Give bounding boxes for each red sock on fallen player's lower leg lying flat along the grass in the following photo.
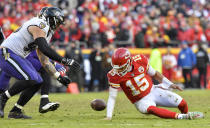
[147,106,176,119]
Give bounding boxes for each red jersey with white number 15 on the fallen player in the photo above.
[107,54,153,103]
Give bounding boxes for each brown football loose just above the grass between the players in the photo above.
[90,99,106,111]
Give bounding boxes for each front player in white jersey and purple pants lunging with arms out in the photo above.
[0,7,80,119]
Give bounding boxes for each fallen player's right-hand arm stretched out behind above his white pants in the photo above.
[147,65,182,91]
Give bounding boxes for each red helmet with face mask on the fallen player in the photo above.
[111,48,132,76]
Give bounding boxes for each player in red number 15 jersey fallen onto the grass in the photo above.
[105,48,204,120]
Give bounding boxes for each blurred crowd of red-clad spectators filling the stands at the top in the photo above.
[0,0,210,48]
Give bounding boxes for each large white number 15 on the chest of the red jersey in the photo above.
[126,73,149,96]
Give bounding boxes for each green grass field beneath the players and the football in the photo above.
[0,90,210,128]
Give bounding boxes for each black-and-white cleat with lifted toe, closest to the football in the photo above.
[39,102,60,113]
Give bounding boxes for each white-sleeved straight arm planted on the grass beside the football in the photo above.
[106,86,118,120]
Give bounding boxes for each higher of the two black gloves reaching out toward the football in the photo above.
[61,58,80,71]
